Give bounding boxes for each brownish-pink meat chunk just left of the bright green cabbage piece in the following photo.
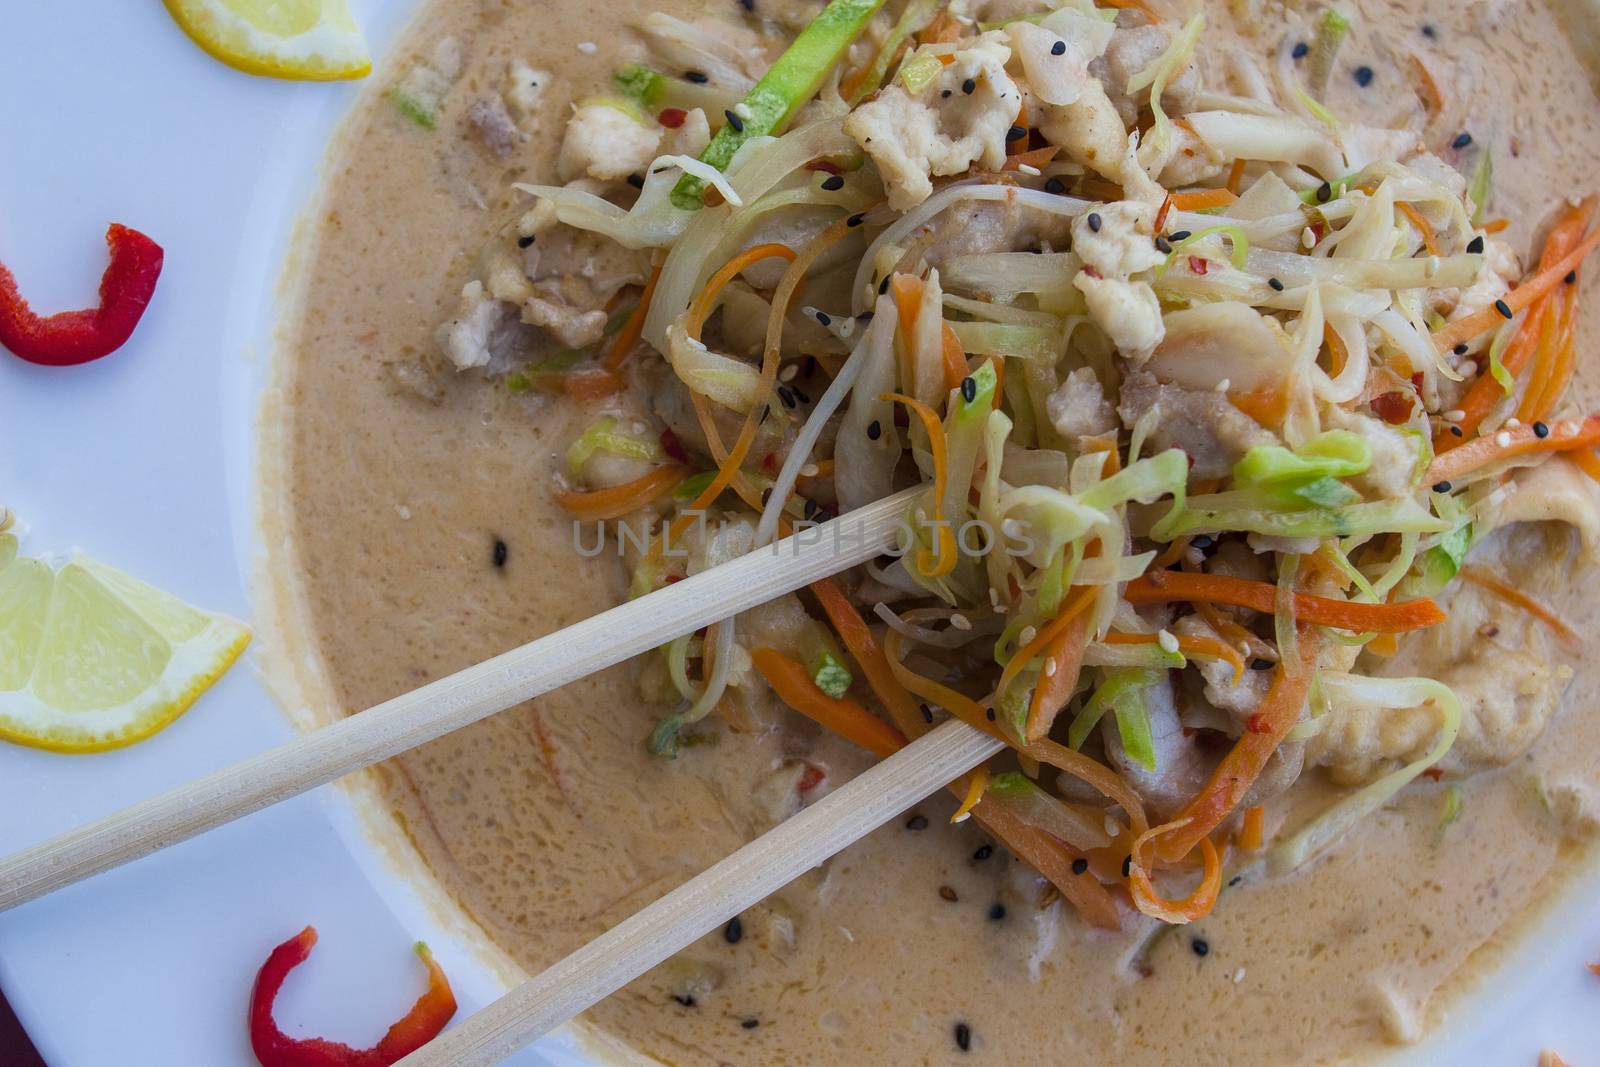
[1117,371,1280,478]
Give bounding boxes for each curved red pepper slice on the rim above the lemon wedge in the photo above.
[0,222,163,366]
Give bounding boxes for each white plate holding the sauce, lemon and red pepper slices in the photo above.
[0,0,1600,1067]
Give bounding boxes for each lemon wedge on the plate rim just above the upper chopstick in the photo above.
[0,534,250,752]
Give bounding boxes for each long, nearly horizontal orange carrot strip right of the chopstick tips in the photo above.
[1123,566,1454,633]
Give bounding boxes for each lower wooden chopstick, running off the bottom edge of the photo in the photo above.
[397,718,1005,1067]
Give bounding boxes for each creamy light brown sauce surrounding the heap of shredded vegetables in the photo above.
[268,0,1600,1067]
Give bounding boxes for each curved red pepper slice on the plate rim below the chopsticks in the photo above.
[250,926,456,1067]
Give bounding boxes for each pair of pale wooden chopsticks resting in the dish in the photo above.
[0,488,1002,1067]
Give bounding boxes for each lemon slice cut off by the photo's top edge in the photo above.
[166,0,373,82]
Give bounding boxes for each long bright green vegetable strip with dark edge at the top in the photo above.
[672,0,883,211]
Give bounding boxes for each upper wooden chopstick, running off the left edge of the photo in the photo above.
[0,488,922,910]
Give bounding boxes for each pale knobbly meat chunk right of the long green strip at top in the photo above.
[845,30,1022,211]
